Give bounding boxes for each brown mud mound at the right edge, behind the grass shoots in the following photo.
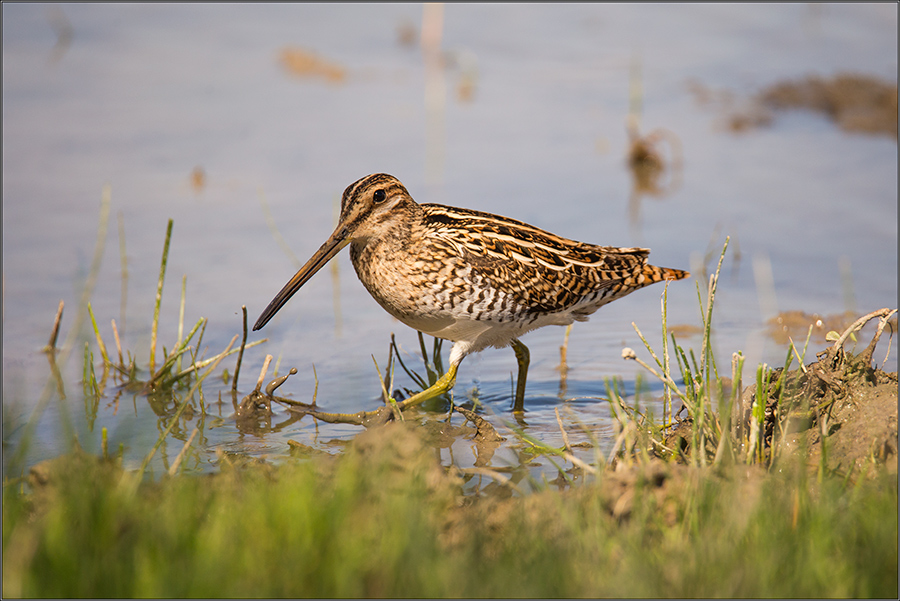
[665,310,898,478]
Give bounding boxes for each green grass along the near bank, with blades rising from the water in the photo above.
[2,205,898,597]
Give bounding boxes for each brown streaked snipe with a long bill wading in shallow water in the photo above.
[253,173,690,411]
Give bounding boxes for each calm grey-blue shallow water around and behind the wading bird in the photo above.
[3,4,897,470]
